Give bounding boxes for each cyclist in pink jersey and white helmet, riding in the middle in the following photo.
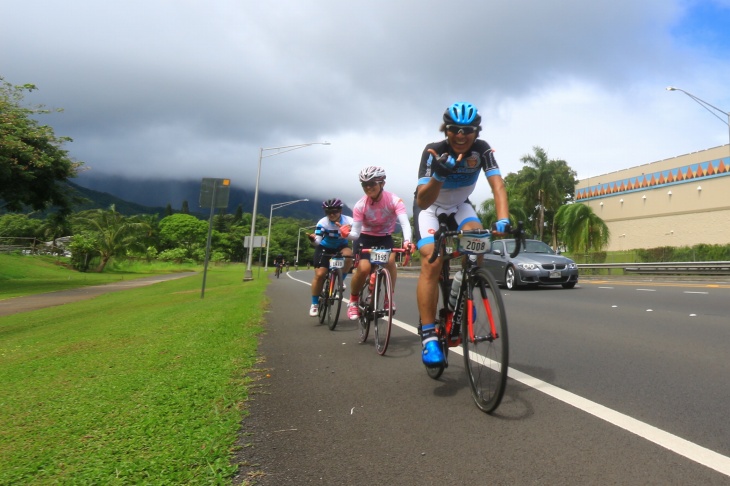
[340,166,412,321]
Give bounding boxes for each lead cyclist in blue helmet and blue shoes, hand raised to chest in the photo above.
[413,103,509,366]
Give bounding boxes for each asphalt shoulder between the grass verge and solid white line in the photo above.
[234,271,726,486]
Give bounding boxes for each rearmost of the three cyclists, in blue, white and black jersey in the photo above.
[309,198,352,317]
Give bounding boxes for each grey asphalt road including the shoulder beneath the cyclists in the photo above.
[232,271,730,485]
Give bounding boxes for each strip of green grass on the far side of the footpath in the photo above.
[0,254,200,300]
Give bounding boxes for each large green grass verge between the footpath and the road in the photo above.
[0,265,268,485]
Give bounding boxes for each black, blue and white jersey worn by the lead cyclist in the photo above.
[418,139,501,209]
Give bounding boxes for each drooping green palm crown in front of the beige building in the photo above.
[555,203,611,253]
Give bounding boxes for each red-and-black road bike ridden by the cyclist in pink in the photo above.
[357,248,410,356]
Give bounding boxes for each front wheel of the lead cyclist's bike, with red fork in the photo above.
[461,269,509,413]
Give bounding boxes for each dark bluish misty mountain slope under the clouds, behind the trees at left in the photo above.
[72,173,336,220]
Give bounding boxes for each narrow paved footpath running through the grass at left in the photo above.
[0,272,197,317]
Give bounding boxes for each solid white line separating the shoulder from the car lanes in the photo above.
[288,274,730,476]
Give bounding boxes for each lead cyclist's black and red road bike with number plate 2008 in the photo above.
[418,220,525,413]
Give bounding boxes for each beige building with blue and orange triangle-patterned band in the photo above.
[575,145,730,251]
